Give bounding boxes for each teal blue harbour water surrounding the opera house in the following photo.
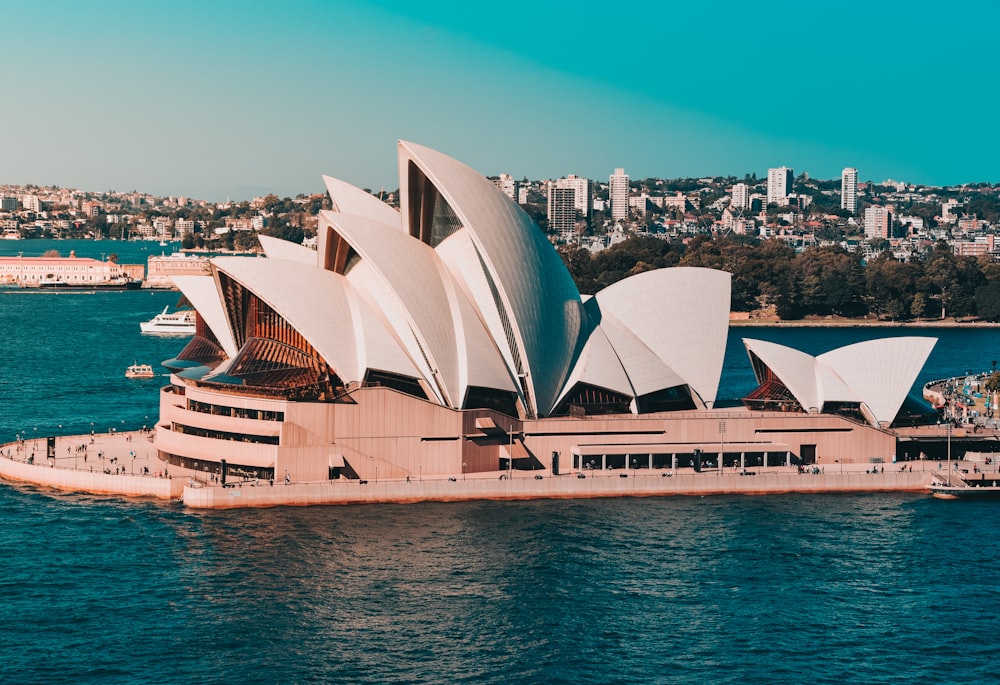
[0,241,1000,684]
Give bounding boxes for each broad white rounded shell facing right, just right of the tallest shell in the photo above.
[594,267,731,406]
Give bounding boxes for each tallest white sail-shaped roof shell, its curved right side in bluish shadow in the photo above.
[399,141,583,415]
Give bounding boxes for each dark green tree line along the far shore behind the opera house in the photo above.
[560,235,1000,325]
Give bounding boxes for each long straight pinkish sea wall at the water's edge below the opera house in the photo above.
[183,471,931,509]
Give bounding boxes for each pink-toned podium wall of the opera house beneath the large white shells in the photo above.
[157,387,896,482]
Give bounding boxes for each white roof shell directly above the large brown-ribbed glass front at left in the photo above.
[212,257,418,383]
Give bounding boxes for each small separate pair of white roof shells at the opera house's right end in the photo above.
[743,336,937,425]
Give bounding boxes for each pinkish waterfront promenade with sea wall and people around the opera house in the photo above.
[0,431,956,509]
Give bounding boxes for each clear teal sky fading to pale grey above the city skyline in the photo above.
[0,0,1000,200]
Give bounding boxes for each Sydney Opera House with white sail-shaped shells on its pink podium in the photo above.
[156,142,934,482]
